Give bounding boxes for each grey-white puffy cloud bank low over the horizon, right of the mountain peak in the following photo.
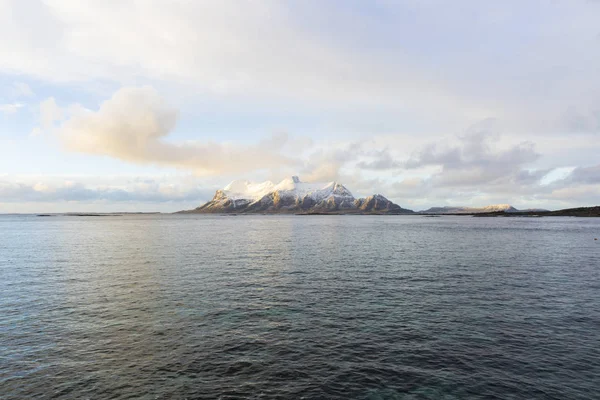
[312,120,563,209]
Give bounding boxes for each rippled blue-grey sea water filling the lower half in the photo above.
[0,215,600,400]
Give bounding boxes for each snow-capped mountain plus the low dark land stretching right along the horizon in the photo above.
[178,176,600,217]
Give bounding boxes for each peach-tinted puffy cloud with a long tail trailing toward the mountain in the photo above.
[55,86,297,176]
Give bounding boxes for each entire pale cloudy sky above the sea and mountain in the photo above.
[0,0,600,213]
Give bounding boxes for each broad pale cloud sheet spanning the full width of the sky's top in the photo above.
[0,0,600,138]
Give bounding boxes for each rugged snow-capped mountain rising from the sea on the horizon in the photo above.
[183,176,413,214]
